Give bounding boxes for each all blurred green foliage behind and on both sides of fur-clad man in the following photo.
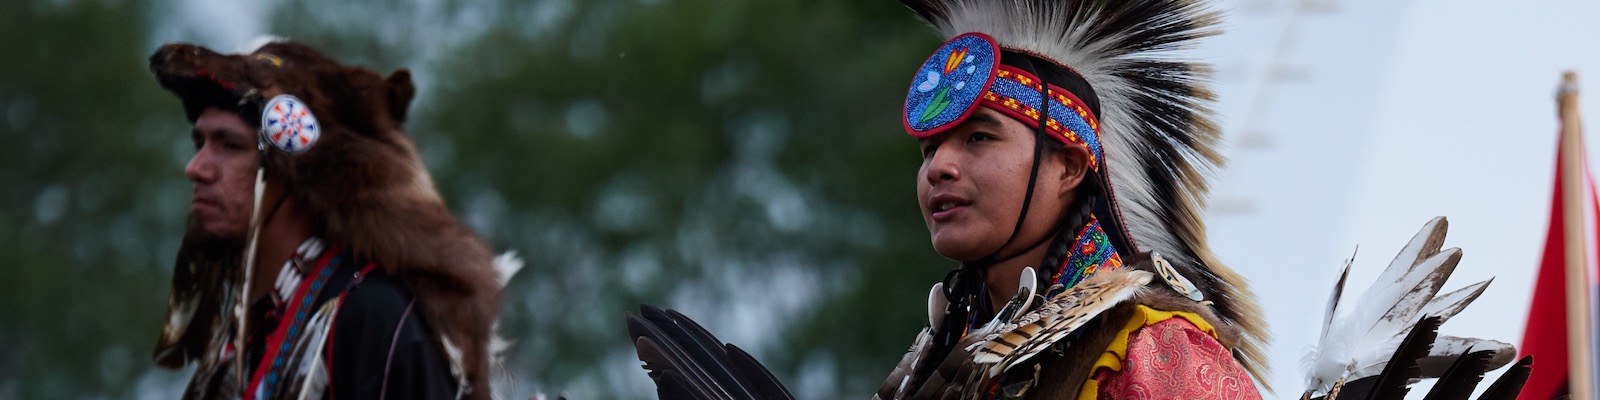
[0,0,950,398]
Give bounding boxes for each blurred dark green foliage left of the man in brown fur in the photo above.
[0,2,189,398]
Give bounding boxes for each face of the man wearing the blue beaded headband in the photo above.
[917,107,1077,262]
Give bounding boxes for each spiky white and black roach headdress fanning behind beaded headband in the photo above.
[902,0,1267,378]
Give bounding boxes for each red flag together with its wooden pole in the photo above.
[1517,75,1600,400]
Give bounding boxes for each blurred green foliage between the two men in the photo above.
[274,0,949,398]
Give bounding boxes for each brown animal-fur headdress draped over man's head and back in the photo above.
[150,42,501,398]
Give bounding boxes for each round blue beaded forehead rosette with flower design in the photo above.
[901,34,1000,138]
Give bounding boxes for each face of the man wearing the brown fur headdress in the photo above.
[184,109,259,237]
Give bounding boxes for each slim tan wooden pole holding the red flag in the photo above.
[1555,72,1595,400]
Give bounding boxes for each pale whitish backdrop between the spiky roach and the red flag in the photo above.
[1198,0,1600,393]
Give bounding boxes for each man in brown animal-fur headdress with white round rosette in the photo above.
[150,42,502,398]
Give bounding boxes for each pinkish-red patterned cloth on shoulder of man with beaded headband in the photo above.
[1096,318,1261,400]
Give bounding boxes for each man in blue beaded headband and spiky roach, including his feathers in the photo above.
[629,0,1526,398]
